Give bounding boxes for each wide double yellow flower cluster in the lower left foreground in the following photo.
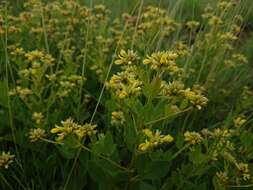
[51,118,97,141]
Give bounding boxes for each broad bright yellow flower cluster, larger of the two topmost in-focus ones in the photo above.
[143,51,179,73]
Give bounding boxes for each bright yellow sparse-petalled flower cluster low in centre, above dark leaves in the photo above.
[138,129,174,151]
